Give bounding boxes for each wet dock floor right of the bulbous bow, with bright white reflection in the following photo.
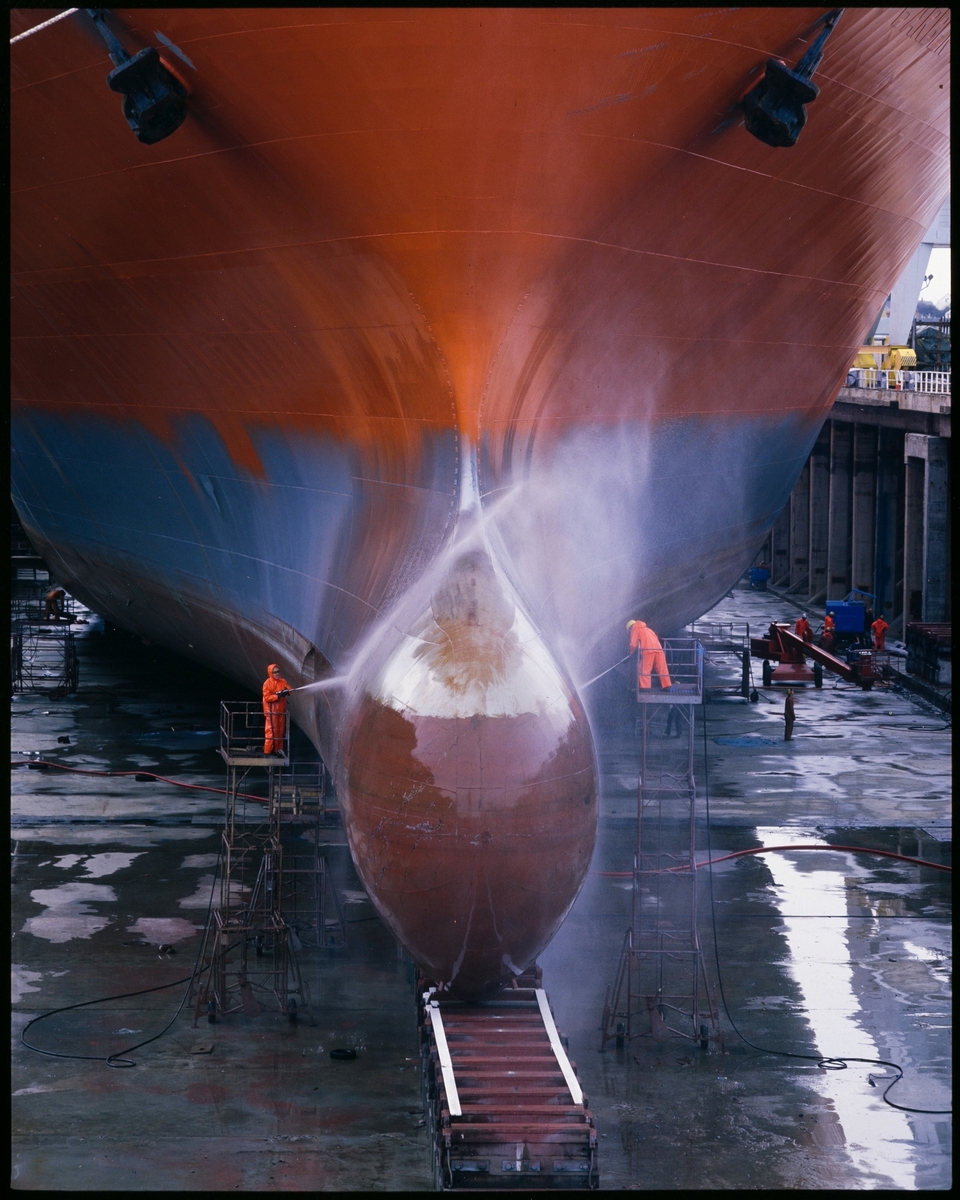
[541,580,952,1189]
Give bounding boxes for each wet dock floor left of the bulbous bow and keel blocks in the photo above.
[12,622,432,1192]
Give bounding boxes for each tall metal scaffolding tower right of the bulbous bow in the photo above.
[600,637,719,1050]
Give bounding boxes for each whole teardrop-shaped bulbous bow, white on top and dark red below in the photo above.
[338,548,598,996]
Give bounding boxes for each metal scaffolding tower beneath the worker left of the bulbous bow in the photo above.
[194,701,346,1025]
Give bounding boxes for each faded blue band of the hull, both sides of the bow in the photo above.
[13,412,816,750]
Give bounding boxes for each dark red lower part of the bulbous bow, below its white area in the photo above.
[340,698,596,996]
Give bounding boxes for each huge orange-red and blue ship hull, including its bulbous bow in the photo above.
[12,8,949,989]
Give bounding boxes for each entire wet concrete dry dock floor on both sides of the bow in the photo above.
[12,588,950,1190]
